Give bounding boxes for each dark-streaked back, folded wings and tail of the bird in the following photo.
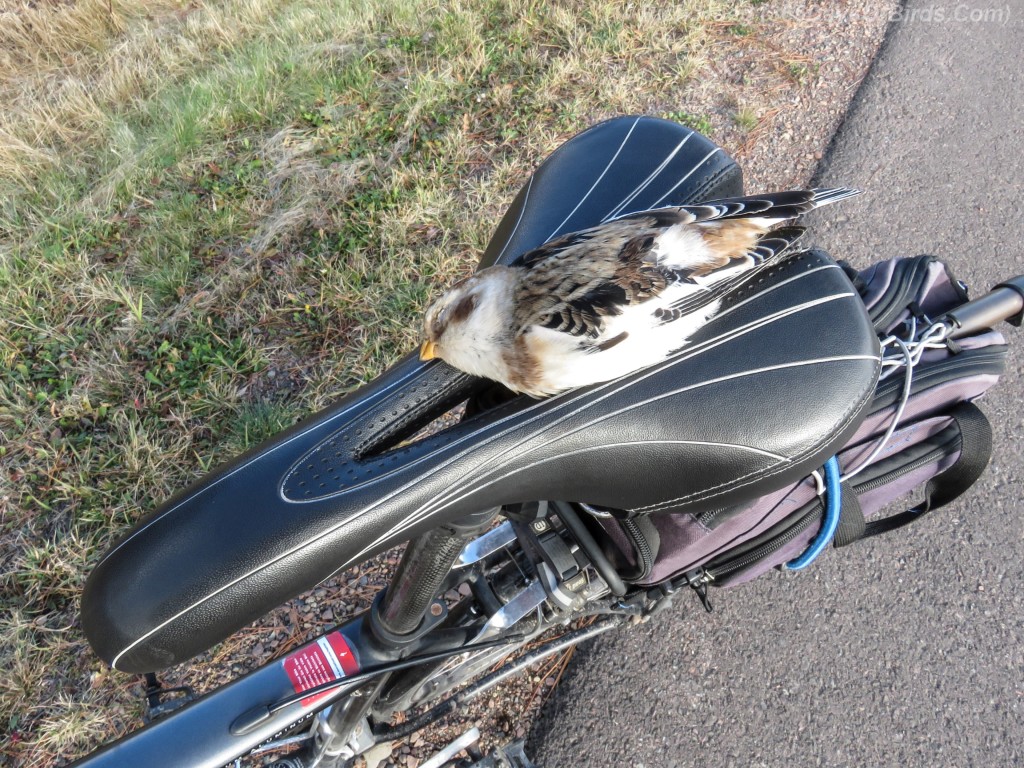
[510,187,859,343]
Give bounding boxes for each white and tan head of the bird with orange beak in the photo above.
[420,266,514,378]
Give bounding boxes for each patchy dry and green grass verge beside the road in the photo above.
[0,0,864,767]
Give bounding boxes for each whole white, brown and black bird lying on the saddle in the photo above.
[420,187,859,397]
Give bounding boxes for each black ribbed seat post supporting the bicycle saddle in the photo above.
[378,508,501,636]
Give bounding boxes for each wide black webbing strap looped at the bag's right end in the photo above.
[860,402,992,546]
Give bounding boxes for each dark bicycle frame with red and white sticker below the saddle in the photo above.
[74,510,612,768]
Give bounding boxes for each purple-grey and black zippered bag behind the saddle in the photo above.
[591,256,1007,598]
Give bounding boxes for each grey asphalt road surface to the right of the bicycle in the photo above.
[528,6,1024,768]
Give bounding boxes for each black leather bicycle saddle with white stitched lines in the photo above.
[82,117,879,672]
